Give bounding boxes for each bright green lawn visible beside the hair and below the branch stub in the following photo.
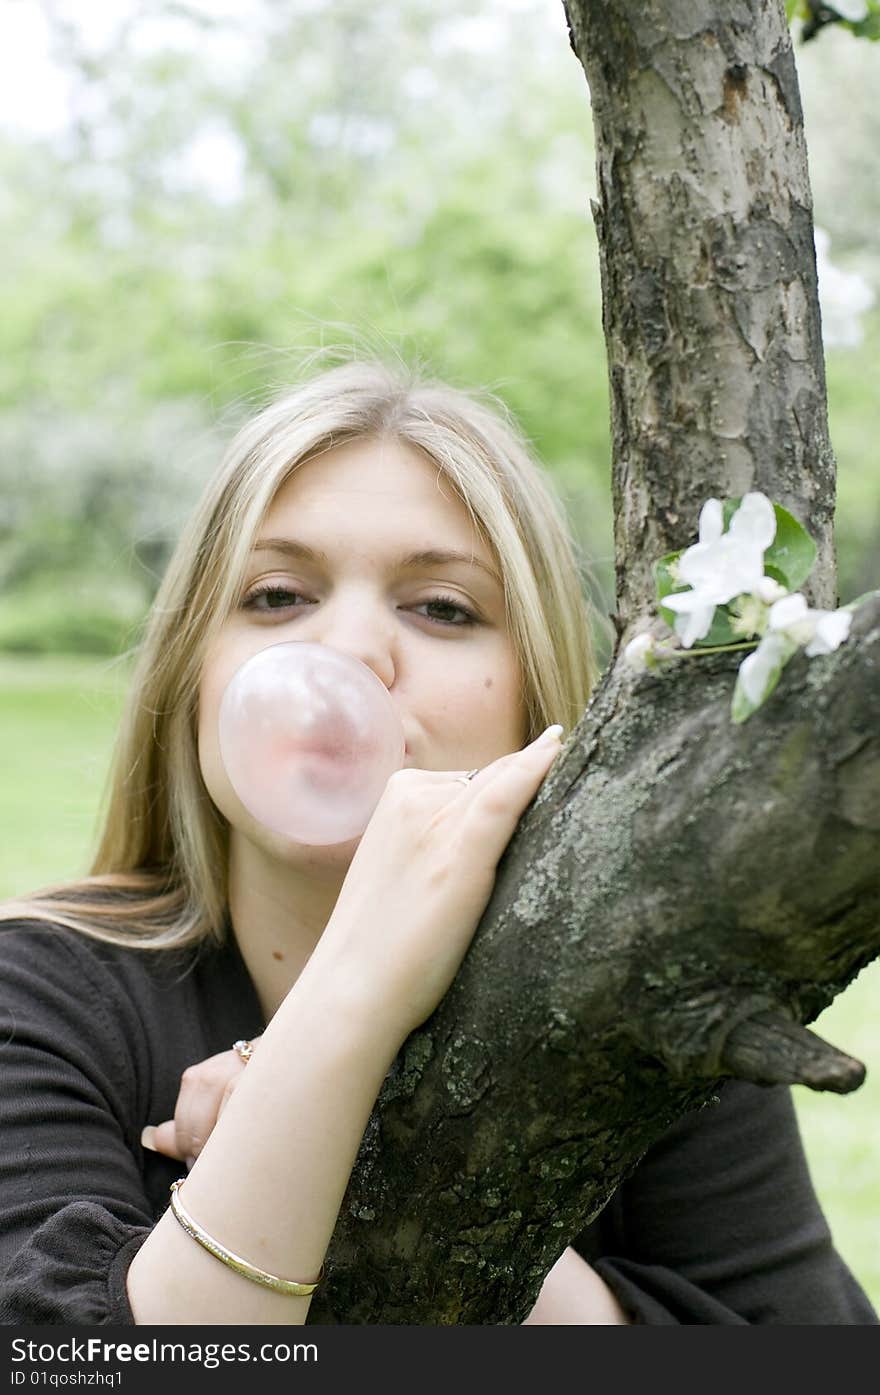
[0,654,880,1309]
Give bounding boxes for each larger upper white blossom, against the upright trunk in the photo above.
[662,492,777,649]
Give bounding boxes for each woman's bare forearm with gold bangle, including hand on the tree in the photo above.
[127,728,561,1324]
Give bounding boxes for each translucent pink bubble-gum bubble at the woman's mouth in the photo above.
[219,640,406,845]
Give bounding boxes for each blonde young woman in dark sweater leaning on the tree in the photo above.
[0,354,876,1324]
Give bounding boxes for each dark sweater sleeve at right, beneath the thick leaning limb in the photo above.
[575,1080,877,1327]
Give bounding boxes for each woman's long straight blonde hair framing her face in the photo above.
[0,356,595,950]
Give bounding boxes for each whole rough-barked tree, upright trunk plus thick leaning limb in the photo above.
[310,0,880,1325]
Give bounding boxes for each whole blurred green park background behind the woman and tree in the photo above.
[0,0,880,1307]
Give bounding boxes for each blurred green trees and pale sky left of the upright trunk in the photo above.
[0,0,611,650]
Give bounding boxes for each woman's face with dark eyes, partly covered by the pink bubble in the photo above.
[198,439,527,852]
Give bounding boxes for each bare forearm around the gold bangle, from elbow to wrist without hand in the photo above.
[127,963,400,1324]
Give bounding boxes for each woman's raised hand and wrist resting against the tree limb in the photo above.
[309,727,562,1041]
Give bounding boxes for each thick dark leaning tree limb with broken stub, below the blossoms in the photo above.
[310,598,880,1324]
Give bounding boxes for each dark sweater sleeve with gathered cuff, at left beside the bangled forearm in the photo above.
[0,926,155,1324]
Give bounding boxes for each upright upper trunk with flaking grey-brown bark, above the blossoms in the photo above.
[566,0,835,628]
